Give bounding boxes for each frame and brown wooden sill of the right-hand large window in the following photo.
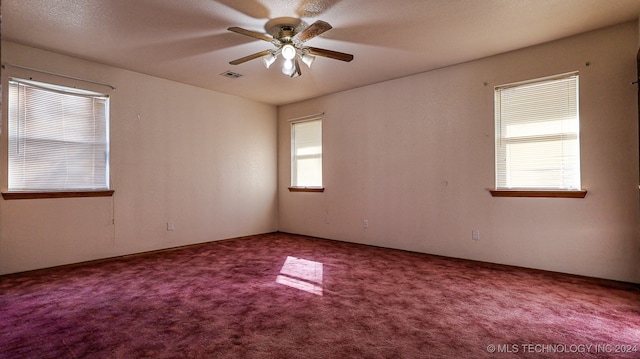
[489,71,587,198]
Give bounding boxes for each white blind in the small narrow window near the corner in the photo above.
[291,119,322,187]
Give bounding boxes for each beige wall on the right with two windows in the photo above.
[278,22,640,282]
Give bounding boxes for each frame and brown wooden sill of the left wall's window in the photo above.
[2,77,115,200]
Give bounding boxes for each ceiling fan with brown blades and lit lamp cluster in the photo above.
[227,17,353,77]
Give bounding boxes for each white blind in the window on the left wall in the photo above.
[8,79,109,192]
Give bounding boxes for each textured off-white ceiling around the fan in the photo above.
[1,0,640,105]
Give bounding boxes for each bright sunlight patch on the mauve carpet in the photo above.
[276,256,322,295]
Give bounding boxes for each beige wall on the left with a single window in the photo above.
[0,41,277,274]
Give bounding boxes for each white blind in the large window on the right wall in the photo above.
[495,73,581,190]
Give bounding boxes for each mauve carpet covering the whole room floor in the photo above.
[0,233,640,359]
